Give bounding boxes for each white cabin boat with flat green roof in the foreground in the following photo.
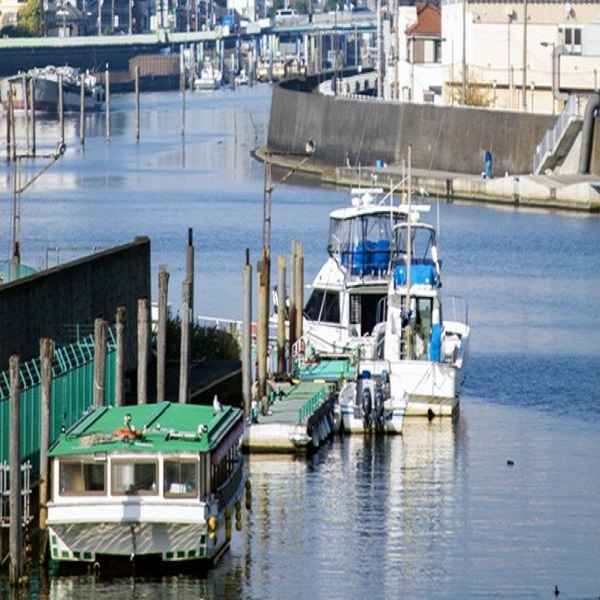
[48,399,245,568]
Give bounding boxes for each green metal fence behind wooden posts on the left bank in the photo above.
[0,327,116,472]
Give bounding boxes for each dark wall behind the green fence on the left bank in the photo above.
[0,237,151,371]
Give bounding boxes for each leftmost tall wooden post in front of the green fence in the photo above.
[9,354,23,586]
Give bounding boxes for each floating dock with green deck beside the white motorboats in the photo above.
[243,360,352,453]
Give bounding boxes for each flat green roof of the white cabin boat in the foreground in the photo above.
[49,402,244,457]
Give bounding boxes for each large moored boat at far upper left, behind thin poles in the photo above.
[0,65,105,112]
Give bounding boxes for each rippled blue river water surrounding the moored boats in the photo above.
[0,85,600,600]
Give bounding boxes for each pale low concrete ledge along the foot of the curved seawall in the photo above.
[254,147,600,214]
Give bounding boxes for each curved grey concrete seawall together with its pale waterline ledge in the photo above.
[268,78,600,212]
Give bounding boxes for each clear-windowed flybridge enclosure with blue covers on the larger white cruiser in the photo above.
[327,211,406,275]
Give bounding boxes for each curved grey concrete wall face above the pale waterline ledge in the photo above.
[267,81,556,175]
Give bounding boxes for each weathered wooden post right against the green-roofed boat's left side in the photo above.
[39,338,54,563]
